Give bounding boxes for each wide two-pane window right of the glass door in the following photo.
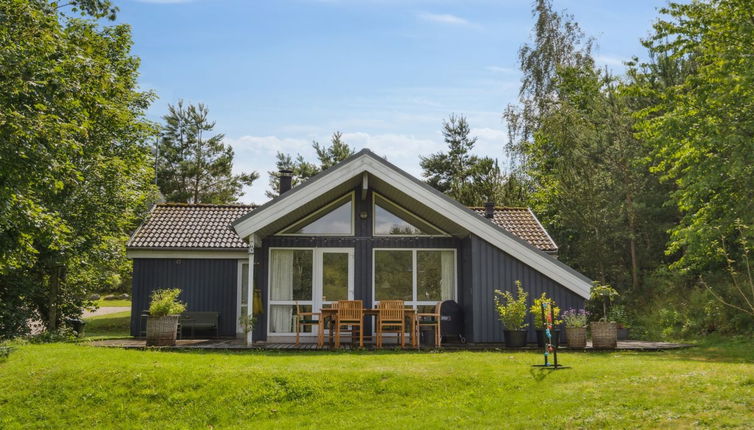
[374,249,456,307]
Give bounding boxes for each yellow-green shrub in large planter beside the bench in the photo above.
[147,288,186,346]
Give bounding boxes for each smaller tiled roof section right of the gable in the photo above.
[469,206,558,252]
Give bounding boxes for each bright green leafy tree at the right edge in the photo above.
[637,0,754,272]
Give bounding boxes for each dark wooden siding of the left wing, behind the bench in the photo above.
[131,258,238,336]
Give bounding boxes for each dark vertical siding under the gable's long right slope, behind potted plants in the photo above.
[463,235,584,342]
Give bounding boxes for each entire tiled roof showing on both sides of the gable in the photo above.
[126,203,558,252]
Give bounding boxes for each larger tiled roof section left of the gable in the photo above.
[126,203,254,249]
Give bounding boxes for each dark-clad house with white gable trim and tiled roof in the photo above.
[127,149,591,342]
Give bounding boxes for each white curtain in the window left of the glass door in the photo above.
[270,249,293,333]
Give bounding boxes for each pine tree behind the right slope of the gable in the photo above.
[420,114,521,206]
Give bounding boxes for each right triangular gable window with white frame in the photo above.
[374,193,447,236]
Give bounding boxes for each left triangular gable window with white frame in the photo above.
[280,194,353,236]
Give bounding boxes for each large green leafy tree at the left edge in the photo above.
[0,0,154,338]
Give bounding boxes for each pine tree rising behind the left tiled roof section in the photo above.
[157,101,259,204]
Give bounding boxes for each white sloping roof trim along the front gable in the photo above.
[233,150,591,298]
